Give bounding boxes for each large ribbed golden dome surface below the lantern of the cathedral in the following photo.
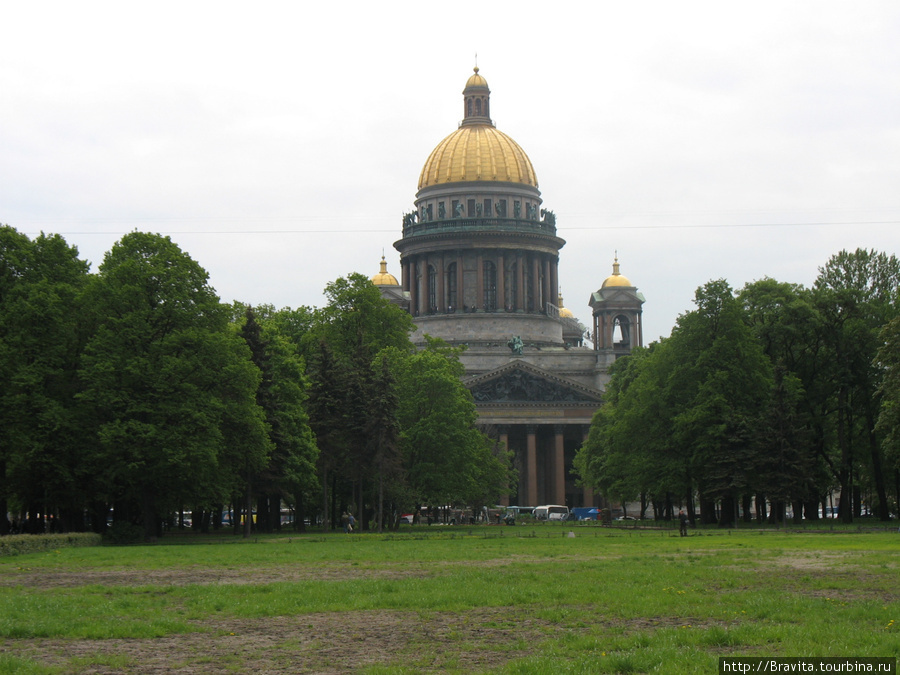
[419,124,538,190]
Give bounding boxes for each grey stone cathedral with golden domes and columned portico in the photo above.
[372,67,644,508]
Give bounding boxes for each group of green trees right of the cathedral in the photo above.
[575,249,900,525]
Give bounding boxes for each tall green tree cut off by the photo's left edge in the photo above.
[0,226,89,534]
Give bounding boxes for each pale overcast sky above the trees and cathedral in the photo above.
[0,0,900,342]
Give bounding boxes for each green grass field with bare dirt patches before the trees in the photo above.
[0,525,900,675]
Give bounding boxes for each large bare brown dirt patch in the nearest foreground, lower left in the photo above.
[0,610,552,675]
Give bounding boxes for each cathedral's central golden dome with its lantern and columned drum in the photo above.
[394,69,565,330]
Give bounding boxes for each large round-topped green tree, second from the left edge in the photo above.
[81,232,270,537]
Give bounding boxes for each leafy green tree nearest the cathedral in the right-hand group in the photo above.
[576,280,772,524]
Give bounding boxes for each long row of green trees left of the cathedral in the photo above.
[0,226,515,537]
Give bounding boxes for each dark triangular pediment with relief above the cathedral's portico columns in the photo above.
[463,360,602,405]
